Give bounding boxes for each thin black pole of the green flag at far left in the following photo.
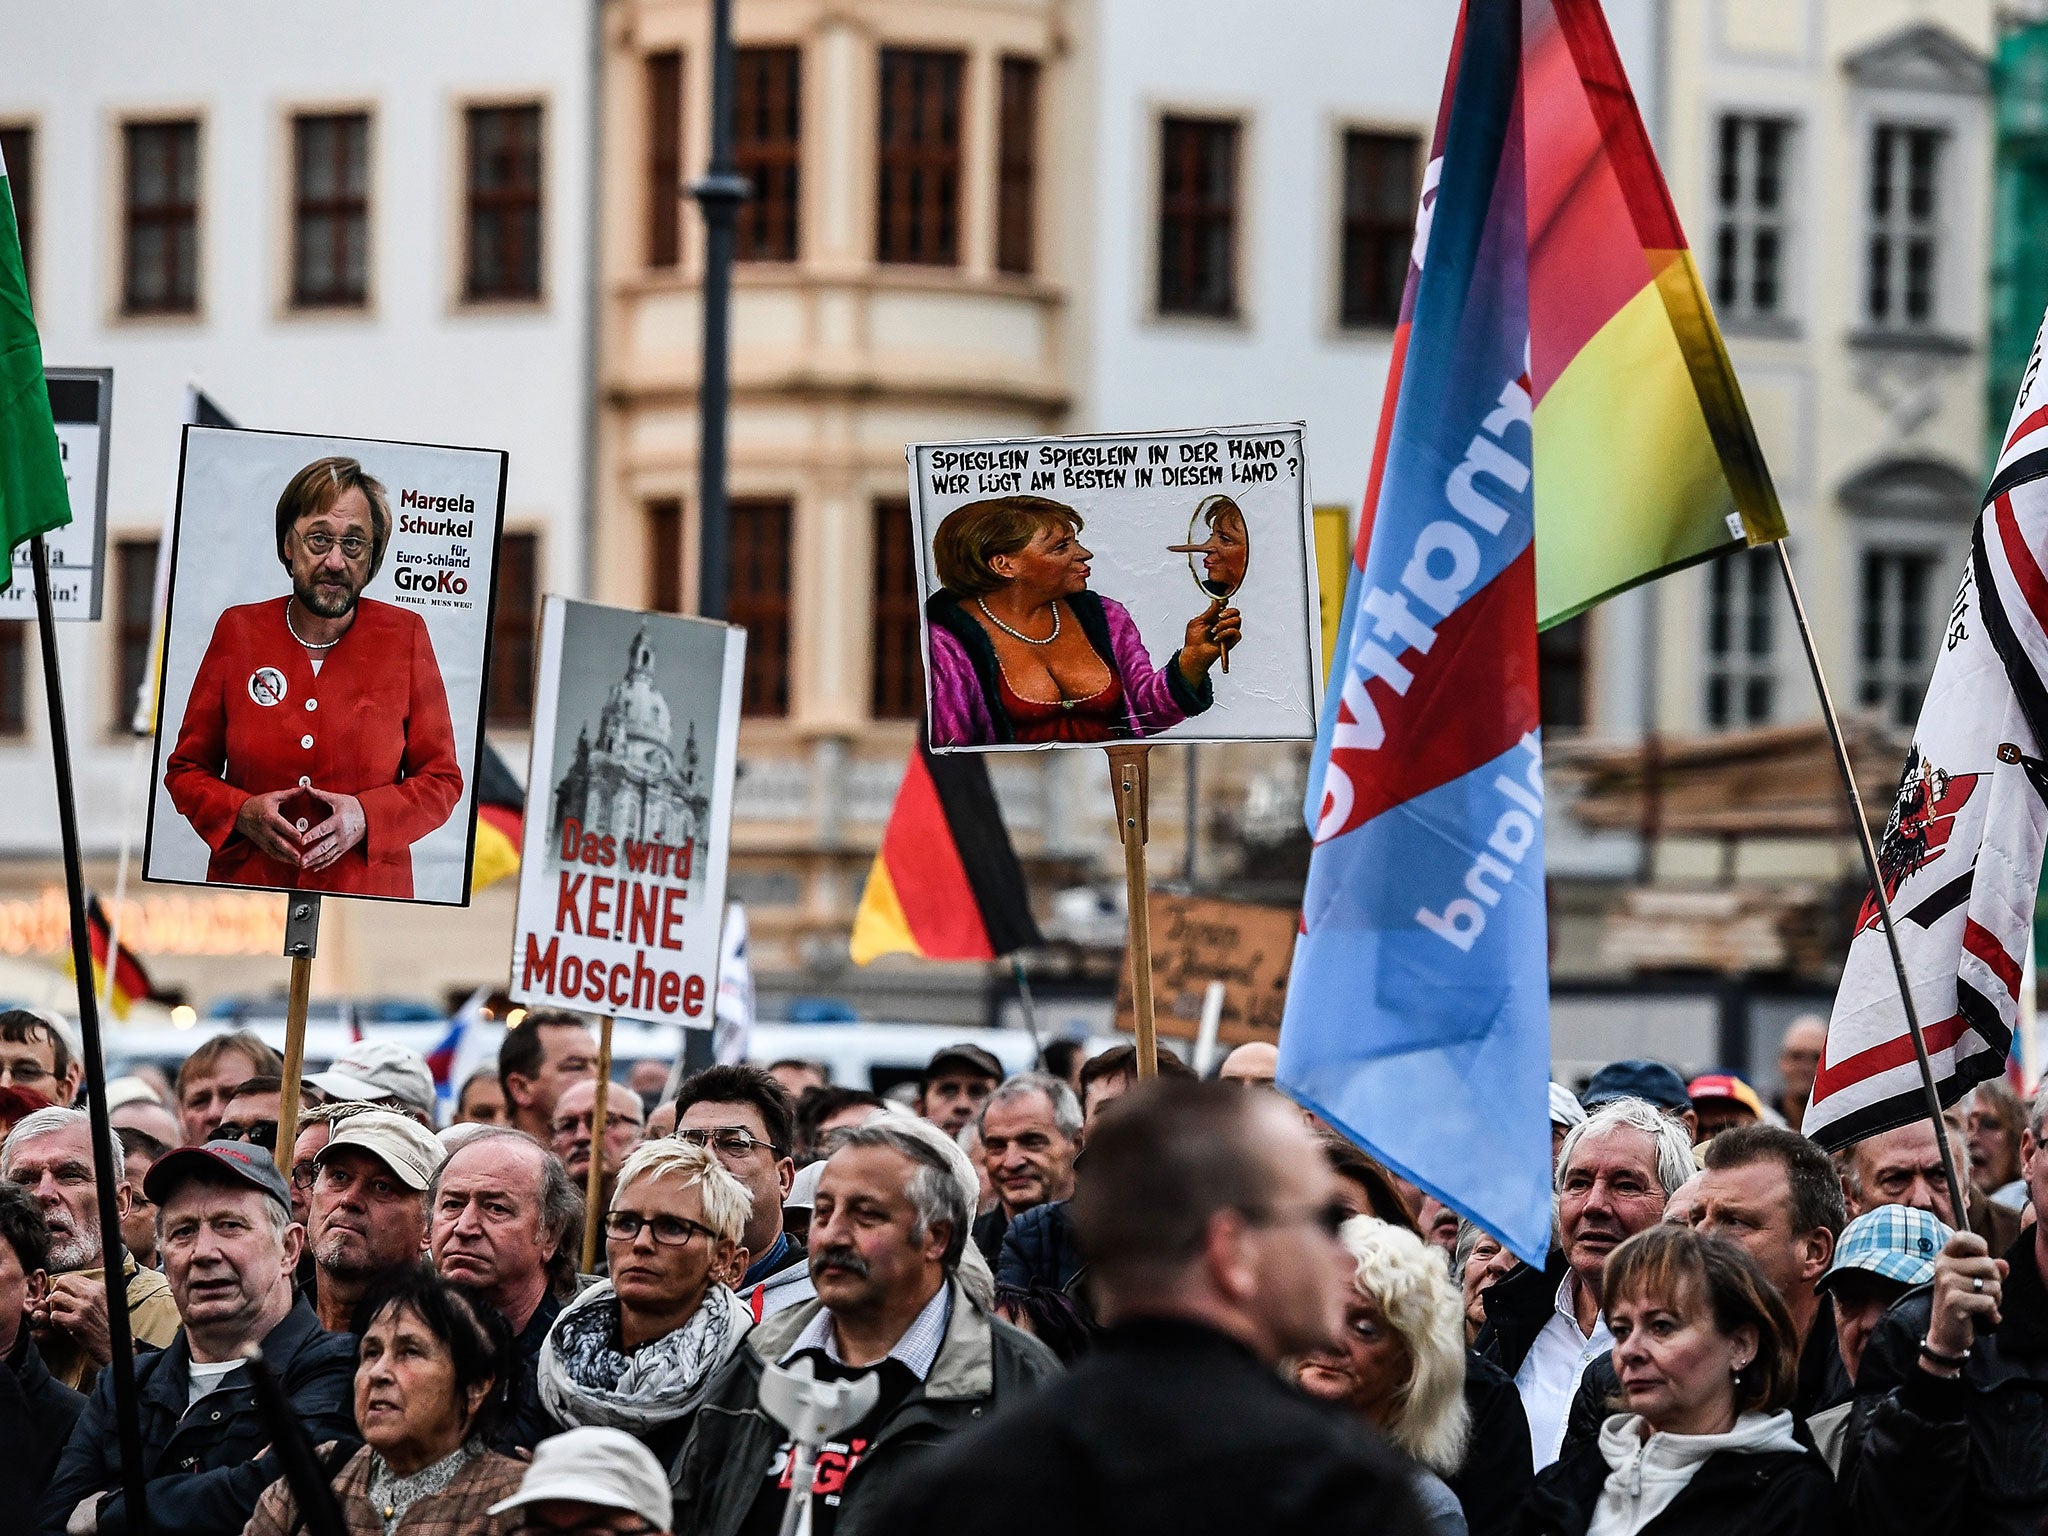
[29,535,150,1532]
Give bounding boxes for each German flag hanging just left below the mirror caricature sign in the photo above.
[848,731,1044,965]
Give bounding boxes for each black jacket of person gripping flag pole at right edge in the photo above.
[1849,1227,2048,1536]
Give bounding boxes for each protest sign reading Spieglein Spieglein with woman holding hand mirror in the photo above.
[907,422,1323,752]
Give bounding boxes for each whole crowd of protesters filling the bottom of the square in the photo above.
[0,1012,2048,1536]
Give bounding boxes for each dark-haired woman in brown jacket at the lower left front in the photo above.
[244,1266,526,1536]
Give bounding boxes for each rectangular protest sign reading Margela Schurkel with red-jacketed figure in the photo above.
[143,426,506,905]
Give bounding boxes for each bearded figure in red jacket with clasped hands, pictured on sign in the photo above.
[164,457,463,897]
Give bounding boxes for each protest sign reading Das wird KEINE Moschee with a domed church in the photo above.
[512,596,745,1030]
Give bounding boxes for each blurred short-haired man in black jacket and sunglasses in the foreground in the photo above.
[881,1079,1423,1536]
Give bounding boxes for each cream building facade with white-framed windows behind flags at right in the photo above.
[1552,0,1997,921]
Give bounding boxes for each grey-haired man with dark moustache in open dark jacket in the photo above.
[674,1114,1059,1536]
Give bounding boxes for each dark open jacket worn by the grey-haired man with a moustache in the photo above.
[670,1280,1059,1536]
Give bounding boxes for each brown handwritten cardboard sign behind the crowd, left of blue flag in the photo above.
[1116,895,1300,1044]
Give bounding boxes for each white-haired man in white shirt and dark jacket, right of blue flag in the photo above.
[1475,1098,1698,1473]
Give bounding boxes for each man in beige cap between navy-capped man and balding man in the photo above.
[305,1110,442,1333]
